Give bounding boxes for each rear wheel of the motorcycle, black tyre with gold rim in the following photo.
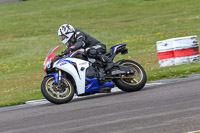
[114,60,147,92]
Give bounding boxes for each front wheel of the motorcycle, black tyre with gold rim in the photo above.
[41,76,74,104]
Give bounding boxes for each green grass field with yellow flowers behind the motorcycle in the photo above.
[0,0,200,106]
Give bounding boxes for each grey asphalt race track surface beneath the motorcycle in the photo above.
[0,76,200,133]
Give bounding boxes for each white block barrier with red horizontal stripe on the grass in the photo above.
[157,36,200,67]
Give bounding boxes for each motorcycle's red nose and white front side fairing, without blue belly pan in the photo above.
[44,48,89,95]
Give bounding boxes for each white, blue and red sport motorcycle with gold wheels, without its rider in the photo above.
[41,44,147,104]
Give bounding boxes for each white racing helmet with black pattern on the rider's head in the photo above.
[58,24,75,47]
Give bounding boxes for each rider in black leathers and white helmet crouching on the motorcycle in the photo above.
[58,24,113,71]
